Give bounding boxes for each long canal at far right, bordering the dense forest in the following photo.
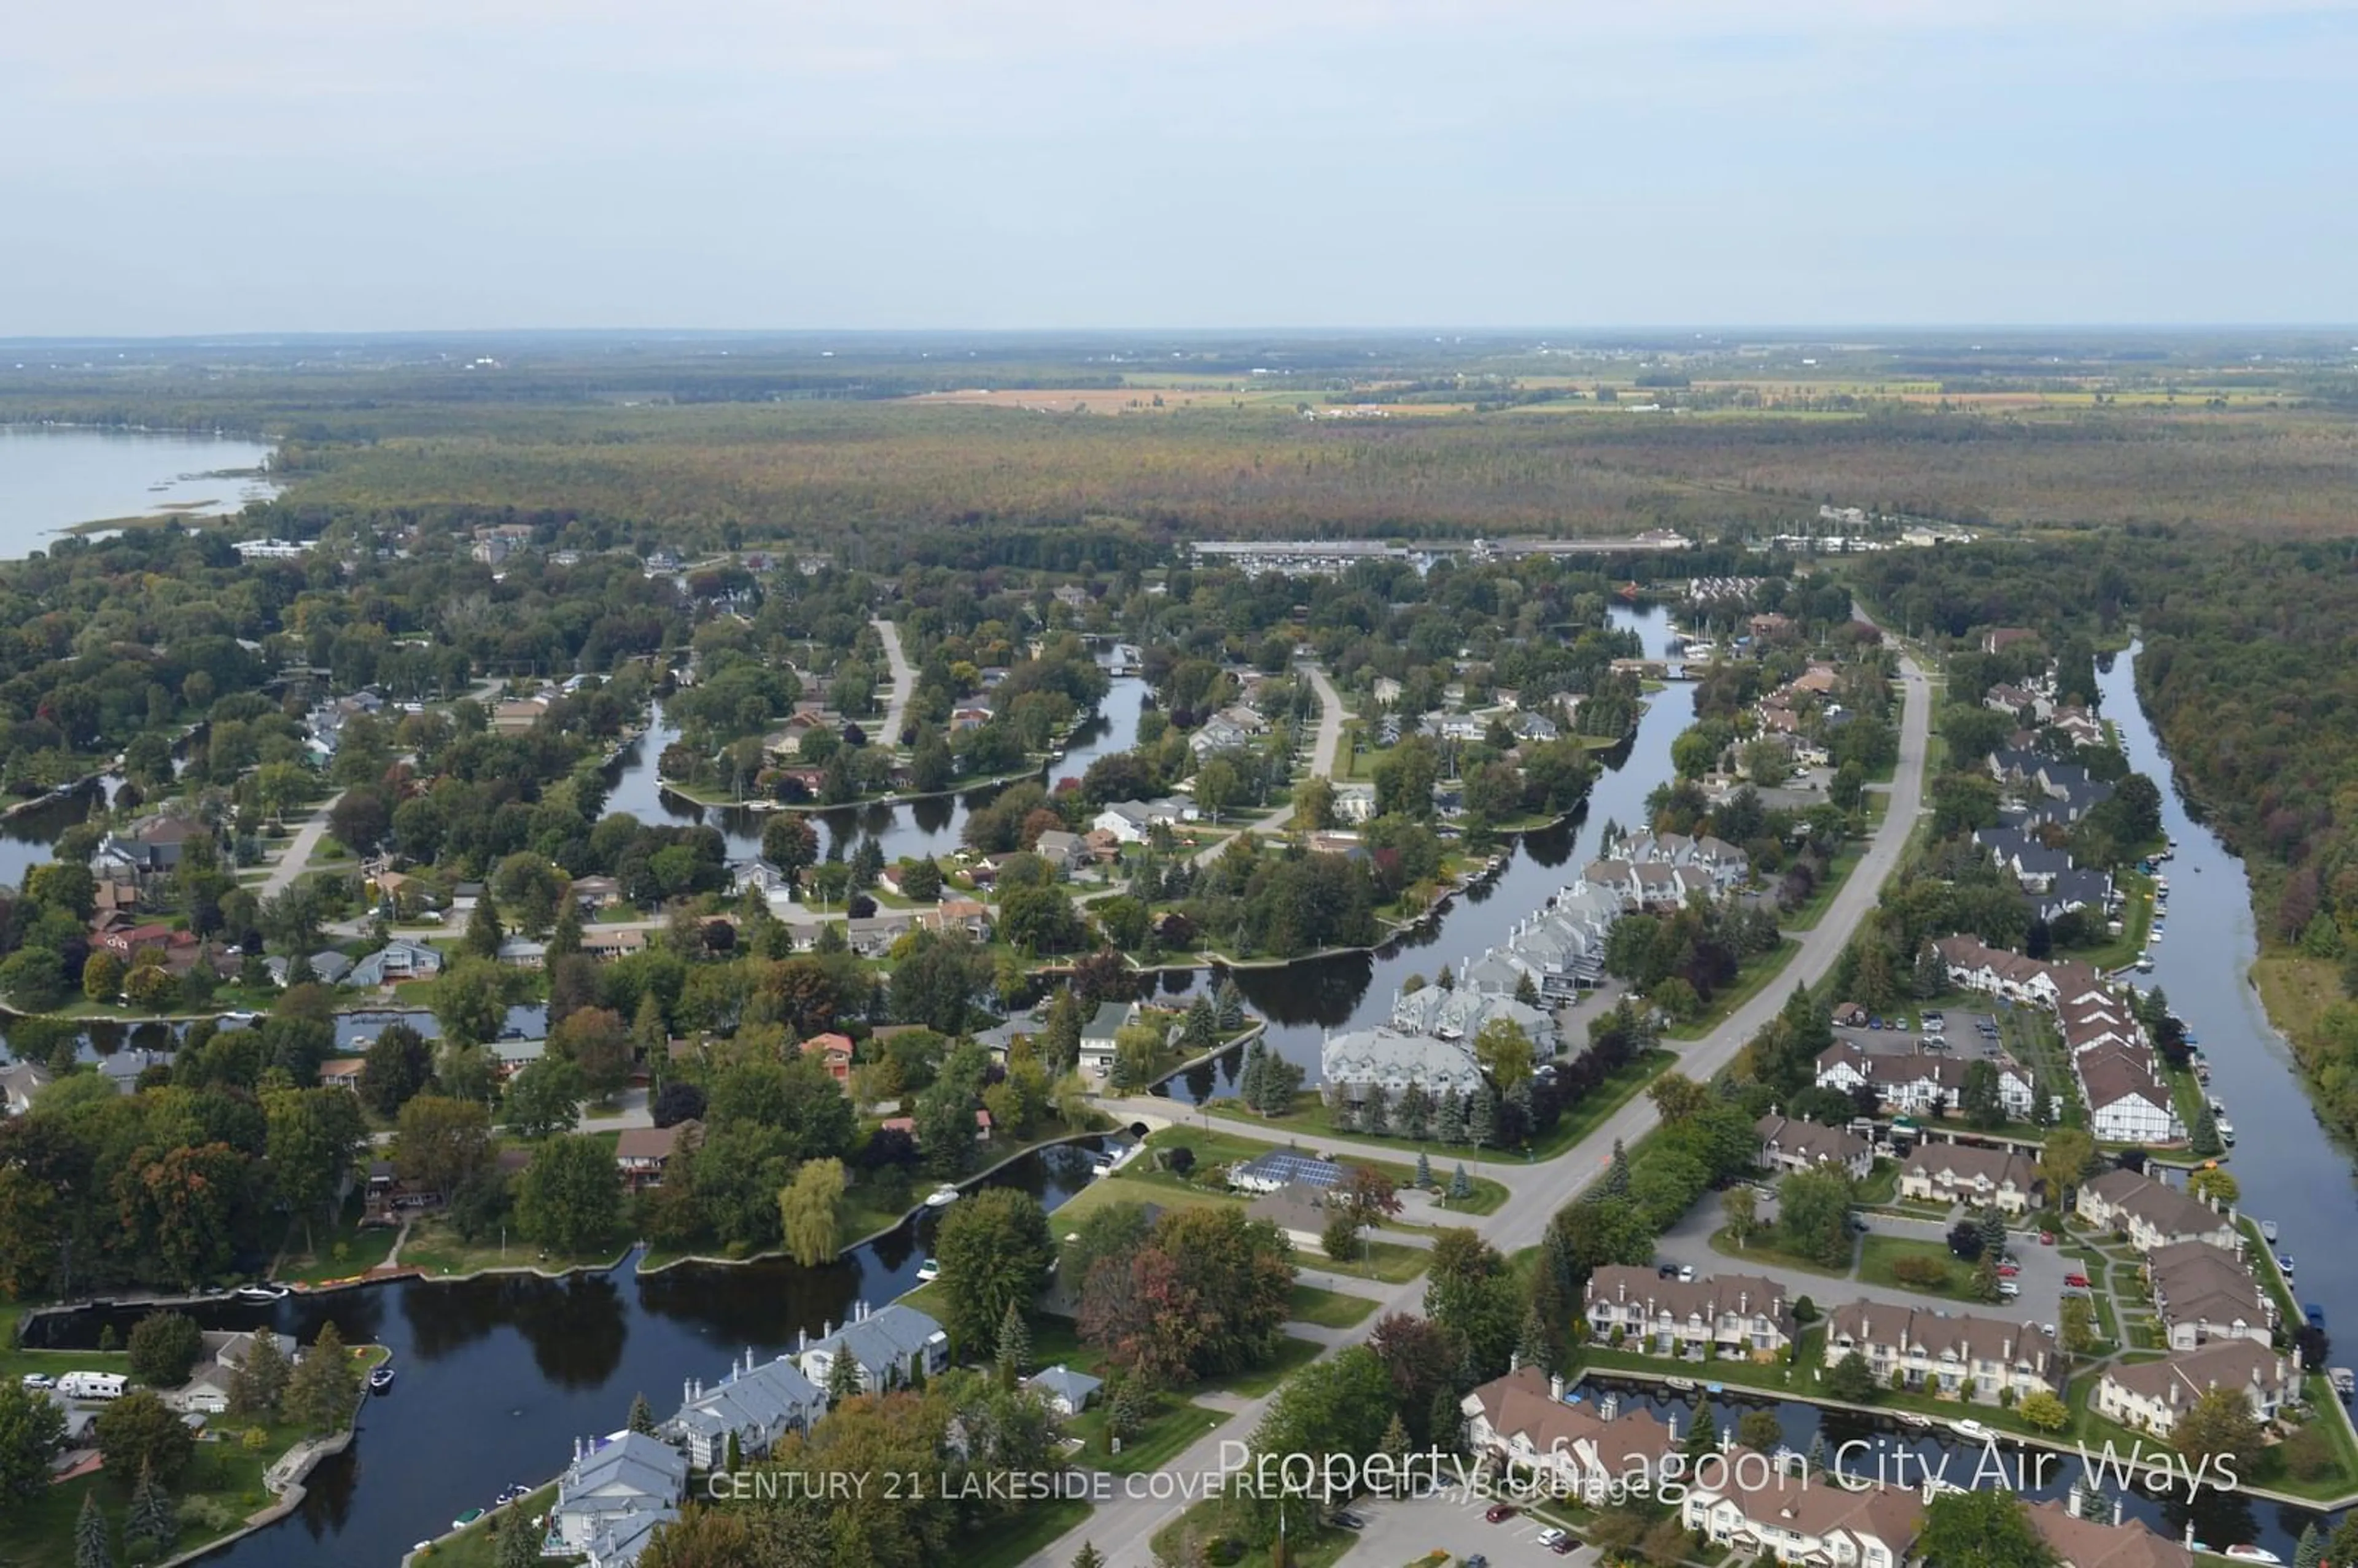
[2096,646,2358,1335]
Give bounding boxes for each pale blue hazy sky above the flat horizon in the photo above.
[0,0,2358,337]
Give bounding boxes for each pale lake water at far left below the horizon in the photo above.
[0,424,276,559]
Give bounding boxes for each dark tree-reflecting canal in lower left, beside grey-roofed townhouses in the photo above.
[37,1139,1103,1568]
